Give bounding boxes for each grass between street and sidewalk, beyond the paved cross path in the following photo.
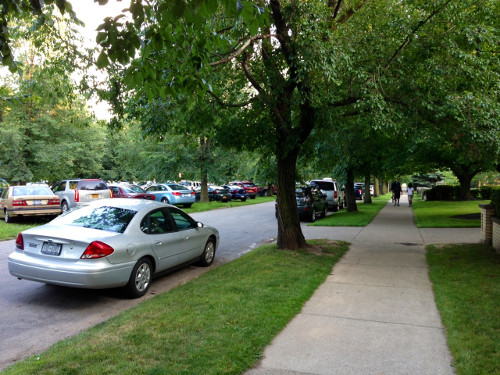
[309,194,391,227]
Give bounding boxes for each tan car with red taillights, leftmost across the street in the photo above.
[0,185,61,223]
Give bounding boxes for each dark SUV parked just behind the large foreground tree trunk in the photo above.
[275,186,328,222]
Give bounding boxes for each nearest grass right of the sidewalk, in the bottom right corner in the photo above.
[427,244,500,375]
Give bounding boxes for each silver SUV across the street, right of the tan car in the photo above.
[52,178,112,212]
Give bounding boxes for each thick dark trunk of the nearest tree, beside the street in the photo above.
[277,148,307,250]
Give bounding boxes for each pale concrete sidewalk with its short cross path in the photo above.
[247,196,480,375]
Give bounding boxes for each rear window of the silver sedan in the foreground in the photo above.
[53,206,137,233]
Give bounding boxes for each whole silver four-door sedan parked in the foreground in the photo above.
[8,198,219,297]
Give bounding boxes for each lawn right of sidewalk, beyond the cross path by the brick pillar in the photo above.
[413,198,490,228]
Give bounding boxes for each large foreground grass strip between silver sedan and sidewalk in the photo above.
[4,240,348,375]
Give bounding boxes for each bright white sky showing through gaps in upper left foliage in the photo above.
[69,0,130,120]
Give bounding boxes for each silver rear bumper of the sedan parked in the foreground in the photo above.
[8,251,135,289]
